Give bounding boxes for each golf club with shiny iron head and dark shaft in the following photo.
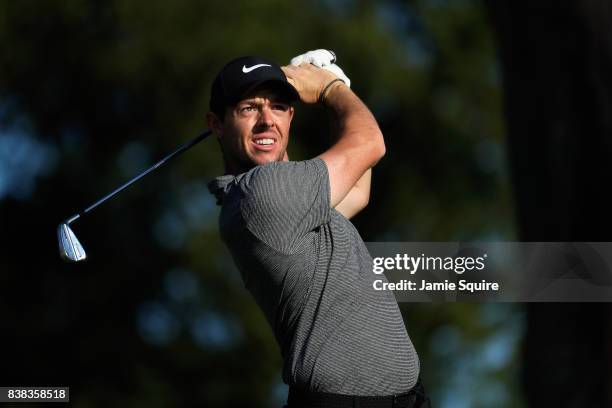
[57,130,211,262]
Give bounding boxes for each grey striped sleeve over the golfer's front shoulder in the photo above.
[241,158,330,252]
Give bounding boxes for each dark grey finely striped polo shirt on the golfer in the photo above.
[209,158,419,395]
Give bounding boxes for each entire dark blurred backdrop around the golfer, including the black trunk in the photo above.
[0,0,612,407]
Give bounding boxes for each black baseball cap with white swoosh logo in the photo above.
[210,56,300,113]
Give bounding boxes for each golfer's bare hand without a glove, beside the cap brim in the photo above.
[282,64,342,103]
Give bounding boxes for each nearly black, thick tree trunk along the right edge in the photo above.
[487,0,612,407]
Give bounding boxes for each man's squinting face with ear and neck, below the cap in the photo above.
[209,88,294,173]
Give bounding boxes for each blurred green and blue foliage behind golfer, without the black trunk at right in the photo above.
[0,0,523,408]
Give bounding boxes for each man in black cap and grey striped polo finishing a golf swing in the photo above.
[207,52,425,407]
